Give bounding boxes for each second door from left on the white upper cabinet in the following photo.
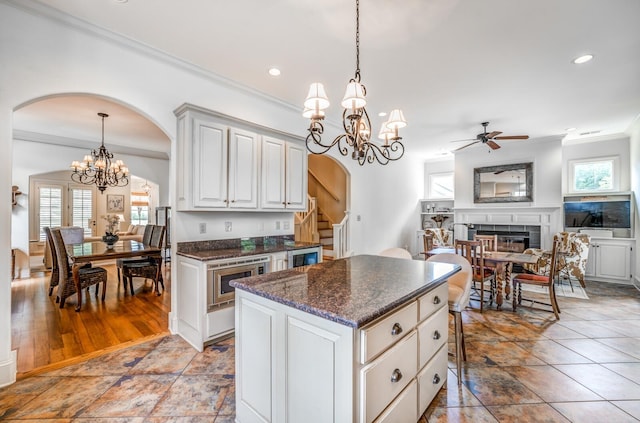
[229,129,259,209]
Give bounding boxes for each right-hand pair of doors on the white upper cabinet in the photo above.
[260,137,307,210]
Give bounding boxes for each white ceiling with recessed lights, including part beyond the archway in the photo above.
[15,0,640,158]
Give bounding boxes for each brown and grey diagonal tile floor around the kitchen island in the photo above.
[0,282,640,423]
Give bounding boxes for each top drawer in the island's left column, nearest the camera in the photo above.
[360,297,420,364]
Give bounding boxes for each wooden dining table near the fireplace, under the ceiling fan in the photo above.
[427,247,538,310]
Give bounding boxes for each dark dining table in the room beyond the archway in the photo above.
[65,240,162,310]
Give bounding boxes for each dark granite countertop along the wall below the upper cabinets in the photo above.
[176,237,320,261]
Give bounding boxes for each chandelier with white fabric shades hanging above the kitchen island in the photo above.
[302,0,407,166]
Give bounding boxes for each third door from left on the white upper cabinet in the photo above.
[260,137,286,209]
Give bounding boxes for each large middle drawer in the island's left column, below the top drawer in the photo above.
[360,330,418,423]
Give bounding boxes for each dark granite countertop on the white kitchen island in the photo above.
[231,255,460,328]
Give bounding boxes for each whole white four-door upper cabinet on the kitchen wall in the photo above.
[175,104,307,211]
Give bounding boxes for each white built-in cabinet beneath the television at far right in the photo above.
[586,238,635,282]
